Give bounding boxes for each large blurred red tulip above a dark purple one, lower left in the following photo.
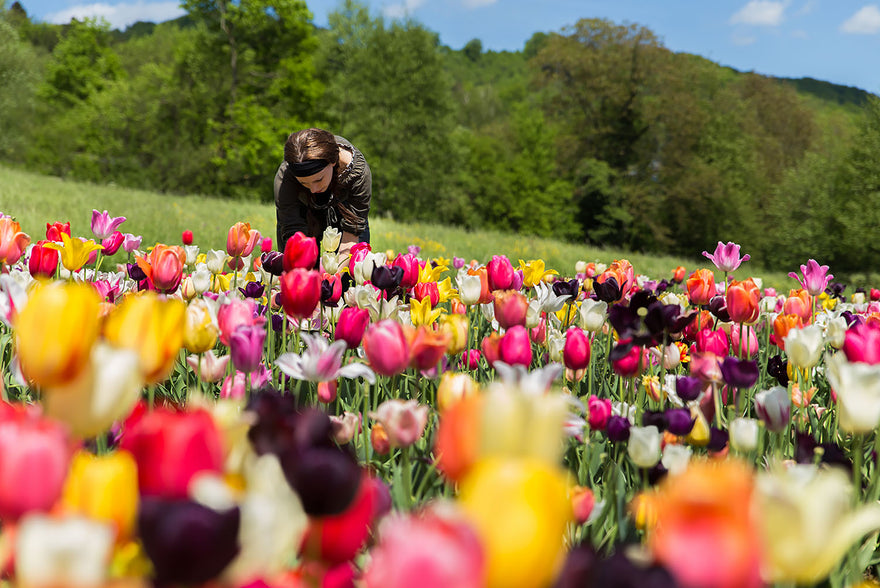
[120,408,224,498]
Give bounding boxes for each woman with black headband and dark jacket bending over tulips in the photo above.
[275,129,373,252]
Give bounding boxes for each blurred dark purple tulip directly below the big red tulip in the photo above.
[138,497,241,585]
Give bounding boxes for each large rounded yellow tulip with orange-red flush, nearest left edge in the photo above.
[14,282,101,386]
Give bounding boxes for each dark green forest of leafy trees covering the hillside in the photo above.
[0,0,880,273]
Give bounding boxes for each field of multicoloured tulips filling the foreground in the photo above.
[0,210,880,588]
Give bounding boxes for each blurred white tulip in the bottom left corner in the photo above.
[15,515,113,587]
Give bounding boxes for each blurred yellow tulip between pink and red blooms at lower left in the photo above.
[61,449,138,544]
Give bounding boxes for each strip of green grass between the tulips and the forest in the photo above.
[0,166,806,291]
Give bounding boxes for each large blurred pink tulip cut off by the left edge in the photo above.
[0,412,72,523]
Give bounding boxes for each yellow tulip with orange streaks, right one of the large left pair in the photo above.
[104,292,186,384]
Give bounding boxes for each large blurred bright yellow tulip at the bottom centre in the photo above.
[459,458,574,588]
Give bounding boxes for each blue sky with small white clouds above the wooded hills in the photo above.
[24,0,880,94]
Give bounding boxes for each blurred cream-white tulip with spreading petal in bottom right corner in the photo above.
[755,465,880,585]
